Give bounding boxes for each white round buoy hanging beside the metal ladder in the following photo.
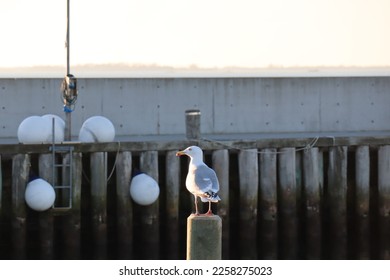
[24,178,56,212]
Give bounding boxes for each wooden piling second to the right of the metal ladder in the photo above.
[91,152,107,259]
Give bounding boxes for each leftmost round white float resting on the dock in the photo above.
[18,116,51,144]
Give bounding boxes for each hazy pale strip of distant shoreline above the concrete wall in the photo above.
[0,63,390,78]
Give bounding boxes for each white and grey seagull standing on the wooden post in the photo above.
[176,146,221,216]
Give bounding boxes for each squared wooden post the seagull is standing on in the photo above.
[187,214,222,260]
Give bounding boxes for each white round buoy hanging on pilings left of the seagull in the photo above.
[130,173,160,205]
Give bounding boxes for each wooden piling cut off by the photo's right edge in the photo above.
[378,146,390,260]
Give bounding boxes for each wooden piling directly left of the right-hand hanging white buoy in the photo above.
[116,152,134,259]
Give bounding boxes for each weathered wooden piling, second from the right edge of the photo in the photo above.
[354,146,370,259]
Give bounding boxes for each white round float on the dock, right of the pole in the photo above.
[79,116,115,142]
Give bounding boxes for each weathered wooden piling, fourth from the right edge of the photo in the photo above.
[303,148,322,260]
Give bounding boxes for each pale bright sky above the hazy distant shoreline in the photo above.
[0,0,390,72]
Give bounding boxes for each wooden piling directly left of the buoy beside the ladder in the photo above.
[11,154,30,259]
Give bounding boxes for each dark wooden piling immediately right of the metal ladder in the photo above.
[63,153,83,260]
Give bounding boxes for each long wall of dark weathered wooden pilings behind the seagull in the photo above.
[0,137,390,259]
